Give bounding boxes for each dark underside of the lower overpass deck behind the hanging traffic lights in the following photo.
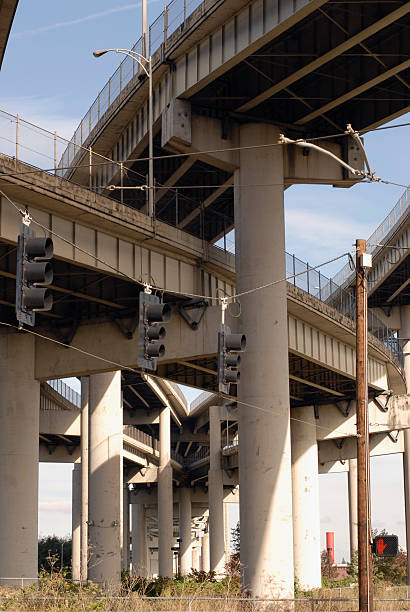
[0,237,386,408]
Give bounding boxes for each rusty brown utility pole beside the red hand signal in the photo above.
[356,240,373,612]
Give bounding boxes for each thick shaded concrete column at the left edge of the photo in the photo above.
[0,333,40,586]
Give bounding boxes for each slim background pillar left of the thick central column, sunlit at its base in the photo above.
[208,406,225,575]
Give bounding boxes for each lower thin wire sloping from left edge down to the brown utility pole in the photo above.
[0,321,357,437]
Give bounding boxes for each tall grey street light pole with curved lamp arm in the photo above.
[93,49,154,218]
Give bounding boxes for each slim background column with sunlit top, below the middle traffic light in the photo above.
[158,407,173,578]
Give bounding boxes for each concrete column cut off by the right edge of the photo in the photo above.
[399,306,410,585]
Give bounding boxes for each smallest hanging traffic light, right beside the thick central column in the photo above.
[218,324,246,393]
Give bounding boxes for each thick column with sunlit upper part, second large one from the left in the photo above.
[88,371,123,586]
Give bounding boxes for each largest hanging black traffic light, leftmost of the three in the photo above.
[16,223,53,327]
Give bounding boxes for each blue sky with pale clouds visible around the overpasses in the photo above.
[0,0,410,560]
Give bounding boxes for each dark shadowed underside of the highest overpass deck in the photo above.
[91,0,410,241]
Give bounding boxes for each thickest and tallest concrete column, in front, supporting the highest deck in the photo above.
[234,123,294,597]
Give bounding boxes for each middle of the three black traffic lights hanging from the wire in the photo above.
[137,291,171,371]
